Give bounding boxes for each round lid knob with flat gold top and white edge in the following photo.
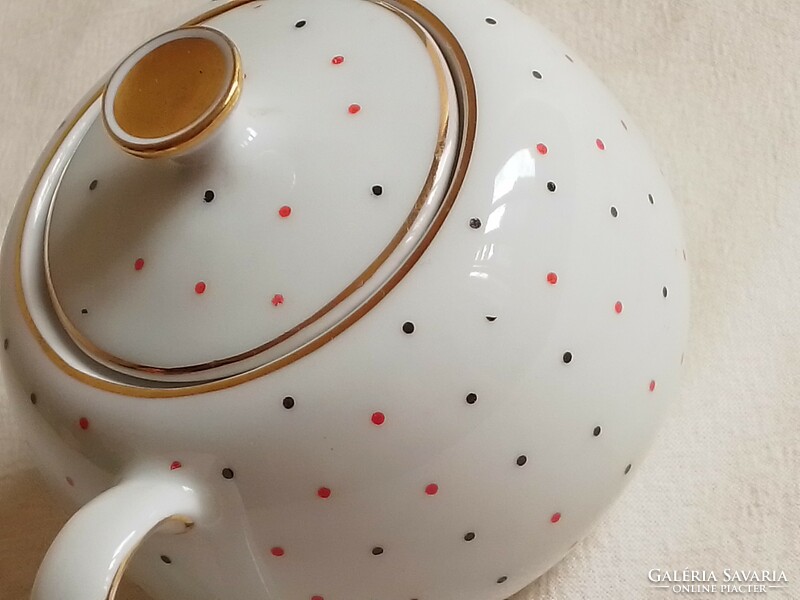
[103,27,242,158]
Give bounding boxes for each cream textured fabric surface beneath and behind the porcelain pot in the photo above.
[0,0,800,600]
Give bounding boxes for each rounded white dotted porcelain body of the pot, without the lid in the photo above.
[0,0,689,600]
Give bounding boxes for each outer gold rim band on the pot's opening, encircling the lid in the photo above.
[16,0,478,398]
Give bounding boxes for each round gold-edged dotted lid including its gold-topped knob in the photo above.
[44,0,461,382]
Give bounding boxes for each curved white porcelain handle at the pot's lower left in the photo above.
[31,480,200,600]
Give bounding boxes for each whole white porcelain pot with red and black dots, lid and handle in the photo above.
[0,0,689,600]
